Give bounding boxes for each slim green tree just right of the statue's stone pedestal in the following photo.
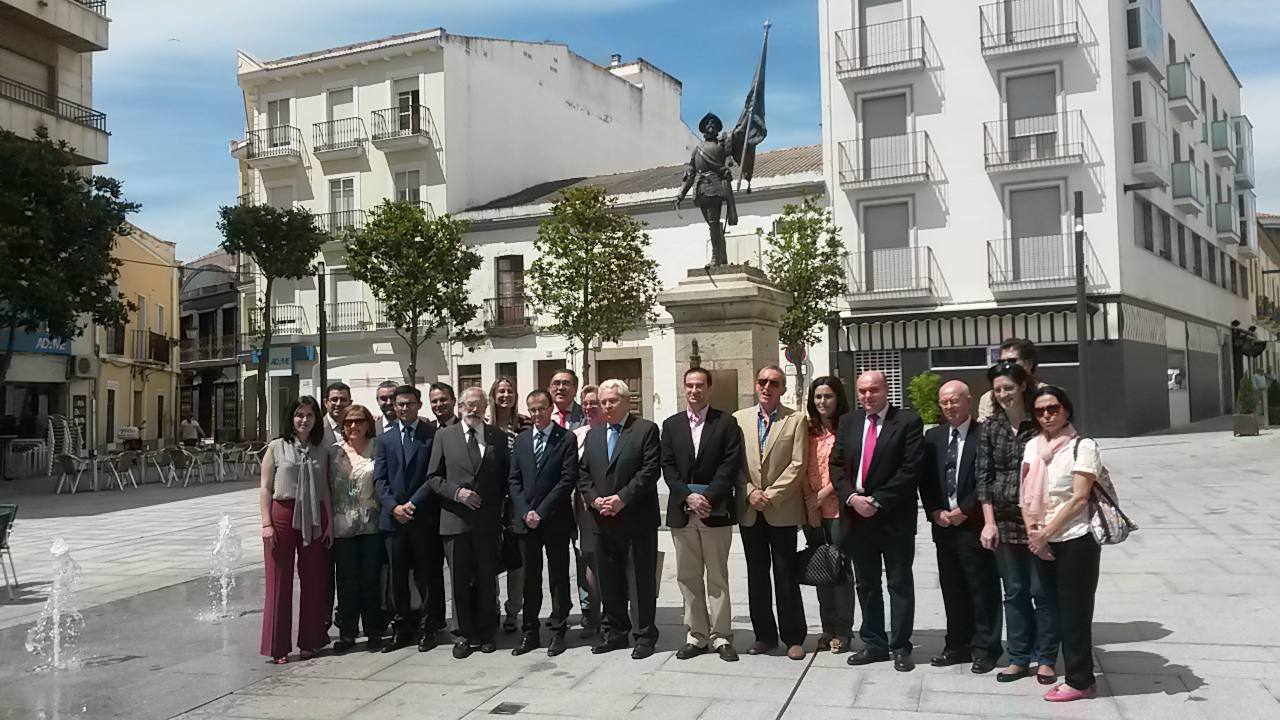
[764,196,845,391]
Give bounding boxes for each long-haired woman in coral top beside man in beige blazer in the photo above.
[804,375,855,652]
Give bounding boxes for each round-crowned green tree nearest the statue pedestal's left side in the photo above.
[527,186,662,384]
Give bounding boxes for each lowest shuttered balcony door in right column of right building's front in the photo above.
[1009,186,1075,282]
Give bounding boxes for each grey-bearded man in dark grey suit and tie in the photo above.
[427,387,511,660]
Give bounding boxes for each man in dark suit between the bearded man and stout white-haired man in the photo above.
[508,389,577,657]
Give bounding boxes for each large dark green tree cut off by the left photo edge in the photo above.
[0,127,141,383]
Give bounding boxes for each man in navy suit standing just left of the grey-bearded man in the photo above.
[374,386,444,652]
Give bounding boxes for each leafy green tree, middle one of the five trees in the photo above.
[347,200,480,384]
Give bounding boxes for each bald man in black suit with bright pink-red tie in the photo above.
[831,370,924,673]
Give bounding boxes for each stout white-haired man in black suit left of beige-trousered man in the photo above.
[577,379,662,660]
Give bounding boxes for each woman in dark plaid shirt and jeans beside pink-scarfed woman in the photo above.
[974,360,1060,685]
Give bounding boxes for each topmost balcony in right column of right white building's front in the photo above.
[978,0,1085,58]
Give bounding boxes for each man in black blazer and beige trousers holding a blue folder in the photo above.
[662,368,742,662]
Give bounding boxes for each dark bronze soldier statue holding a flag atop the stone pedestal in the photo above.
[676,22,772,265]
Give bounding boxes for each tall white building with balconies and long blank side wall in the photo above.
[230,28,695,432]
